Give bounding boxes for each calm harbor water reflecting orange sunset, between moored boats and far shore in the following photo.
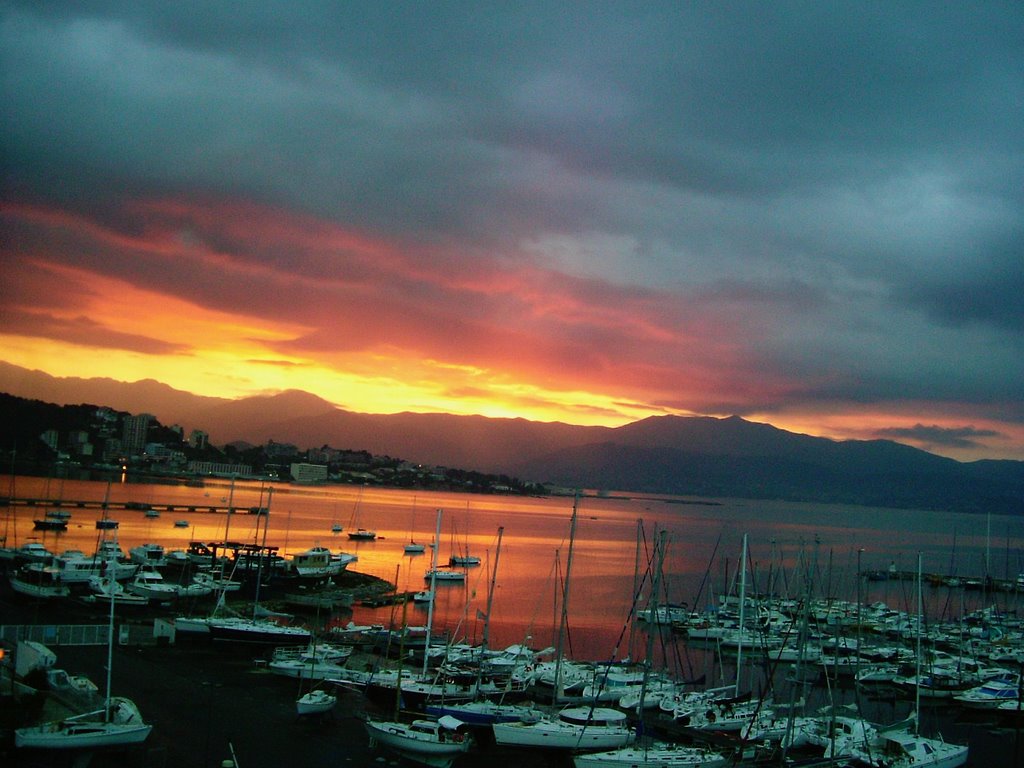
[0,477,1024,765]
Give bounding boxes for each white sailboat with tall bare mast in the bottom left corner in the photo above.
[14,573,153,750]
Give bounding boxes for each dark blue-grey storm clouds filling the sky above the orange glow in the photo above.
[0,2,1024,448]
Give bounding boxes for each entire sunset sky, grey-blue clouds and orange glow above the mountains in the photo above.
[0,0,1024,460]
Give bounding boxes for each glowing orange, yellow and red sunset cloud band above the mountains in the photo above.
[0,198,1015,456]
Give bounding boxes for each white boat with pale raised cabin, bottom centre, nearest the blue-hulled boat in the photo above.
[490,707,635,751]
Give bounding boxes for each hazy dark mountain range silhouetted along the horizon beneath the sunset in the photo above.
[0,362,1024,514]
